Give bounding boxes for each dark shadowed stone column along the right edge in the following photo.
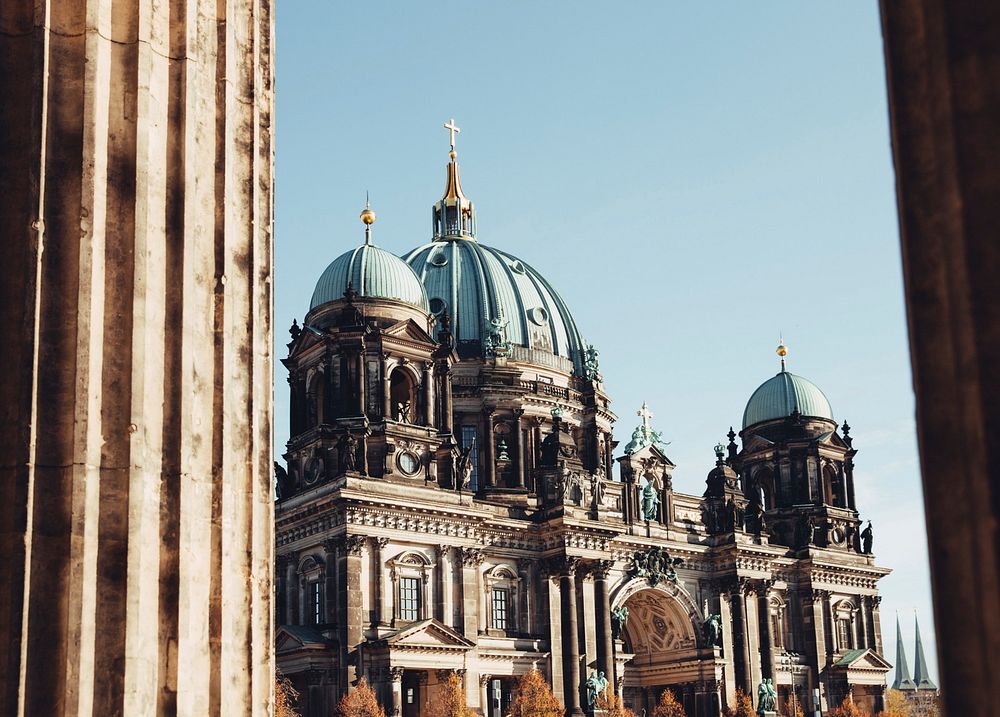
[882,0,1000,717]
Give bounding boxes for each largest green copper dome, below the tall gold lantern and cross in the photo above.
[405,240,585,374]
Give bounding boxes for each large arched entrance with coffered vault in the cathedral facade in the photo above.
[614,578,723,717]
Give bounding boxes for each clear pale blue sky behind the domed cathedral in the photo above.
[275,0,937,680]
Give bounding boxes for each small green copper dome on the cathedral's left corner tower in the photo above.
[309,244,430,311]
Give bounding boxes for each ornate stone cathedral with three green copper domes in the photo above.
[275,122,890,717]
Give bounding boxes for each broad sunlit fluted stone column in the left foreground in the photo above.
[0,0,274,715]
